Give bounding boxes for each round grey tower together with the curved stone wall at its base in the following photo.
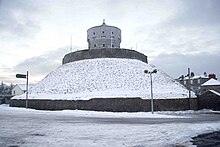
[62,22,148,64]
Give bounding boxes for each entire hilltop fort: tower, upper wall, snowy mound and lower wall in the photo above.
[10,22,198,112]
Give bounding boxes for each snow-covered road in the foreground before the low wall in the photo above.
[0,105,220,147]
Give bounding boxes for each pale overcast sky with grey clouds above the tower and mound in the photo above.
[0,0,220,84]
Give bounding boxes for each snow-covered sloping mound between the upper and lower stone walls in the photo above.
[14,58,193,100]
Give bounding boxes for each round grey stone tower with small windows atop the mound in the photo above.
[87,21,121,49]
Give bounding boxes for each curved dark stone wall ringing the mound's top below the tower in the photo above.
[62,48,148,64]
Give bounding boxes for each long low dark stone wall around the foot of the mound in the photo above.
[10,98,198,112]
